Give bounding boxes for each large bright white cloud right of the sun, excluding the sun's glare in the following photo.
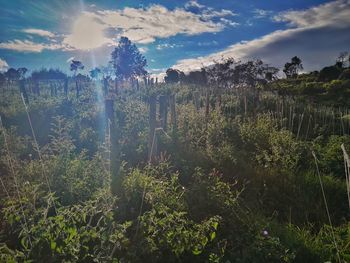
[91,5,230,44]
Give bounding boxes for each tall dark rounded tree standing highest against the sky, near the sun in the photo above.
[110,37,147,89]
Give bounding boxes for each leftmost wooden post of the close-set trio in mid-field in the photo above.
[148,96,157,163]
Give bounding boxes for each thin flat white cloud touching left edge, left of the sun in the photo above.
[0,39,65,53]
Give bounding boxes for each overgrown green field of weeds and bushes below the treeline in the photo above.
[0,83,350,262]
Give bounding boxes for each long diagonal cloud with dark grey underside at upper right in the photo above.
[174,0,350,71]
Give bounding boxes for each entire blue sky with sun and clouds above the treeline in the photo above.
[0,0,350,78]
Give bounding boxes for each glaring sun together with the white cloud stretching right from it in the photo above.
[63,1,237,50]
